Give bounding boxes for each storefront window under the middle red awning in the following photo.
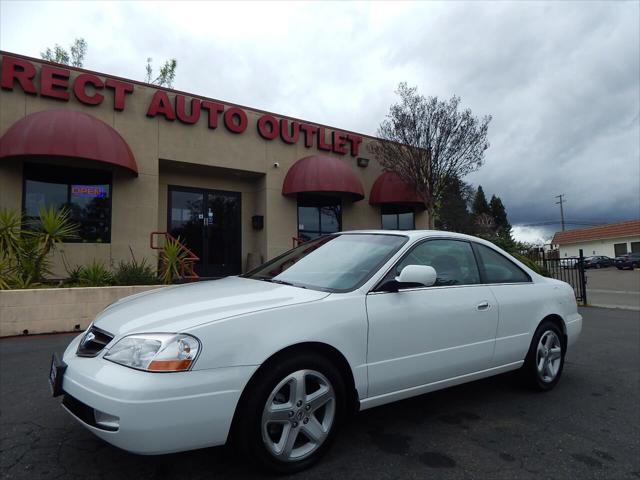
[298,195,342,242]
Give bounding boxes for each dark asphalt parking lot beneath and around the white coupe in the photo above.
[0,308,640,480]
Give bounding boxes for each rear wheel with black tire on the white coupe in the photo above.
[521,320,566,392]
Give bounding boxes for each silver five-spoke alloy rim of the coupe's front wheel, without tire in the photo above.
[261,370,336,462]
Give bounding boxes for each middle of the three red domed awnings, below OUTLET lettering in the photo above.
[282,155,364,201]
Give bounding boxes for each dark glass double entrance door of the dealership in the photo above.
[167,186,242,277]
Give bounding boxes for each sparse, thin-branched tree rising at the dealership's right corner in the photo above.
[370,83,491,227]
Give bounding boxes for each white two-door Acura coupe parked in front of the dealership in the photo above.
[50,231,582,473]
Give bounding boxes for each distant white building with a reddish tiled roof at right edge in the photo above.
[551,220,640,258]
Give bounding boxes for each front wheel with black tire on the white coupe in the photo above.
[232,354,346,475]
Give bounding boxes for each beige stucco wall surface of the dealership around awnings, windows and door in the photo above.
[0,52,428,276]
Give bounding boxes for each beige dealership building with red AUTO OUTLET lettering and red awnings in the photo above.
[0,52,428,277]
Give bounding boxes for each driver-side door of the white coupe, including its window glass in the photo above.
[366,239,498,397]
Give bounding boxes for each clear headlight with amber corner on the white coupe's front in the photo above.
[104,333,200,372]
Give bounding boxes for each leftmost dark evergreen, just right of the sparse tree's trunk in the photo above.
[435,177,474,234]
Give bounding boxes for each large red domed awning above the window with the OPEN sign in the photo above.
[0,110,138,175]
